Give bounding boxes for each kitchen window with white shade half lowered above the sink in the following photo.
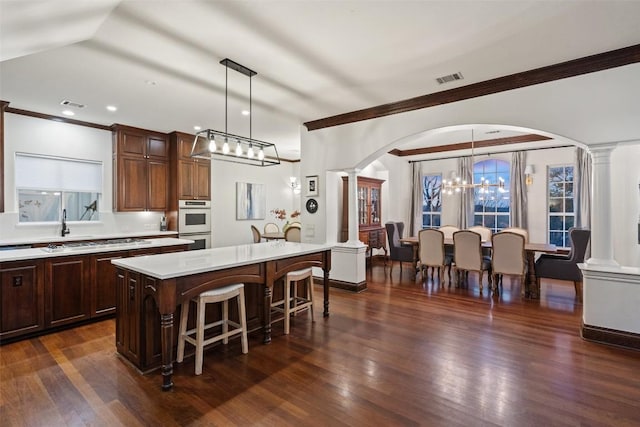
[15,153,102,223]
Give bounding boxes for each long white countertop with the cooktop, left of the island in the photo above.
[0,237,193,262]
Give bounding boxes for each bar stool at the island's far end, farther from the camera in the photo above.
[271,267,315,335]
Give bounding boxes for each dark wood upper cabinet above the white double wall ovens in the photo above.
[169,132,211,203]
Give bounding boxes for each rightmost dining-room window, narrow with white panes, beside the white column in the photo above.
[547,165,574,248]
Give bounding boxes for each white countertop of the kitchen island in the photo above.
[111,240,333,280]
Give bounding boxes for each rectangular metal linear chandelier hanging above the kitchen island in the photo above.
[191,58,280,166]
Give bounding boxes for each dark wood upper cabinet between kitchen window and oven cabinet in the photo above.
[112,125,170,212]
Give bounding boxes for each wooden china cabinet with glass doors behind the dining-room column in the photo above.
[341,176,387,256]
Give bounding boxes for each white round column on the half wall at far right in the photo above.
[586,144,618,266]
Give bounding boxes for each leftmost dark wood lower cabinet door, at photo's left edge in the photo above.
[0,261,44,339]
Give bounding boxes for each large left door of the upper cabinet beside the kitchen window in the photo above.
[117,157,148,211]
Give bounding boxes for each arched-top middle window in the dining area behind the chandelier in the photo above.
[473,159,511,233]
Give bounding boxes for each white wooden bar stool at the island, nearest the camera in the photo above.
[177,283,249,375]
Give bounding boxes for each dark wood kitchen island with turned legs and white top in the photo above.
[111,241,331,390]
